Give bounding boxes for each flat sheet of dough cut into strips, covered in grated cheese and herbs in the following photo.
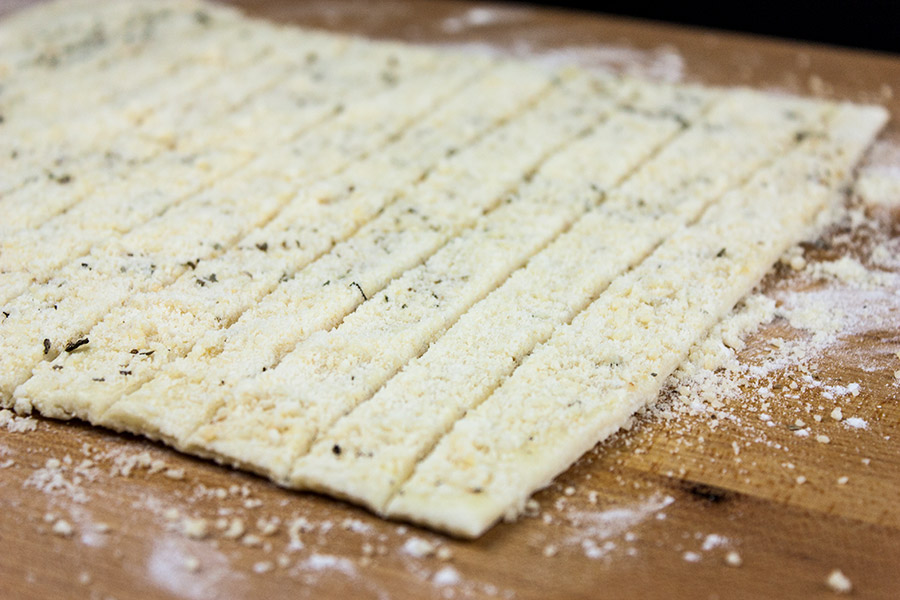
[0,0,887,537]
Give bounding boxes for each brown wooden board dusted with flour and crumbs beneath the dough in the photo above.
[0,0,900,599]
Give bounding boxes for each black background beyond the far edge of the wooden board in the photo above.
[500,0,900,53]
